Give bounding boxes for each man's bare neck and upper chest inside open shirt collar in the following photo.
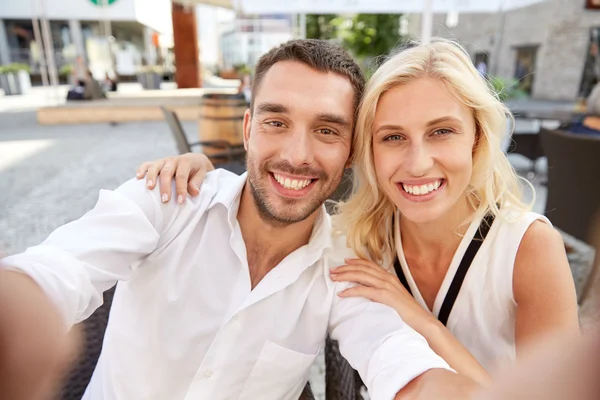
[237,182,320,289]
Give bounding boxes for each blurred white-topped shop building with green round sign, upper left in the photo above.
[0,0,172,77]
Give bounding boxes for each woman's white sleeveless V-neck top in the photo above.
[394,210,551,372]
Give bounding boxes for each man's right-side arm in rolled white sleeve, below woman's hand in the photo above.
[329,276,477,400]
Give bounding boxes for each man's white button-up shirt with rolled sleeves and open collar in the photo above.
[5,170,448,400]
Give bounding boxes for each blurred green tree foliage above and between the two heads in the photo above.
[341,14,405,60]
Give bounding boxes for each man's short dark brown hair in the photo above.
[250,39,365,123]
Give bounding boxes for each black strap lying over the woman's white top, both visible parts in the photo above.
[394,214,494,325]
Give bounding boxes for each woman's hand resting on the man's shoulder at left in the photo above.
[136,153,215,204]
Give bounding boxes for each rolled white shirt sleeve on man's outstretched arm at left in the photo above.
[2,180,161,327]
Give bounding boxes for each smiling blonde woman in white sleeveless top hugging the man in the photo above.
[138,40,579,383]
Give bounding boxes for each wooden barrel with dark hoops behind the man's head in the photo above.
[198,94,247,154]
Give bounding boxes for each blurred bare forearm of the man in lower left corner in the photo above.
[0,268,81,400]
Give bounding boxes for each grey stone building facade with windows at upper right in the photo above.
[418,0,600,101]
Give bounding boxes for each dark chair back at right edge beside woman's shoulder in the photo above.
[540,128,600,243]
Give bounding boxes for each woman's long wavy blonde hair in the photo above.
[334,38,533,262]
